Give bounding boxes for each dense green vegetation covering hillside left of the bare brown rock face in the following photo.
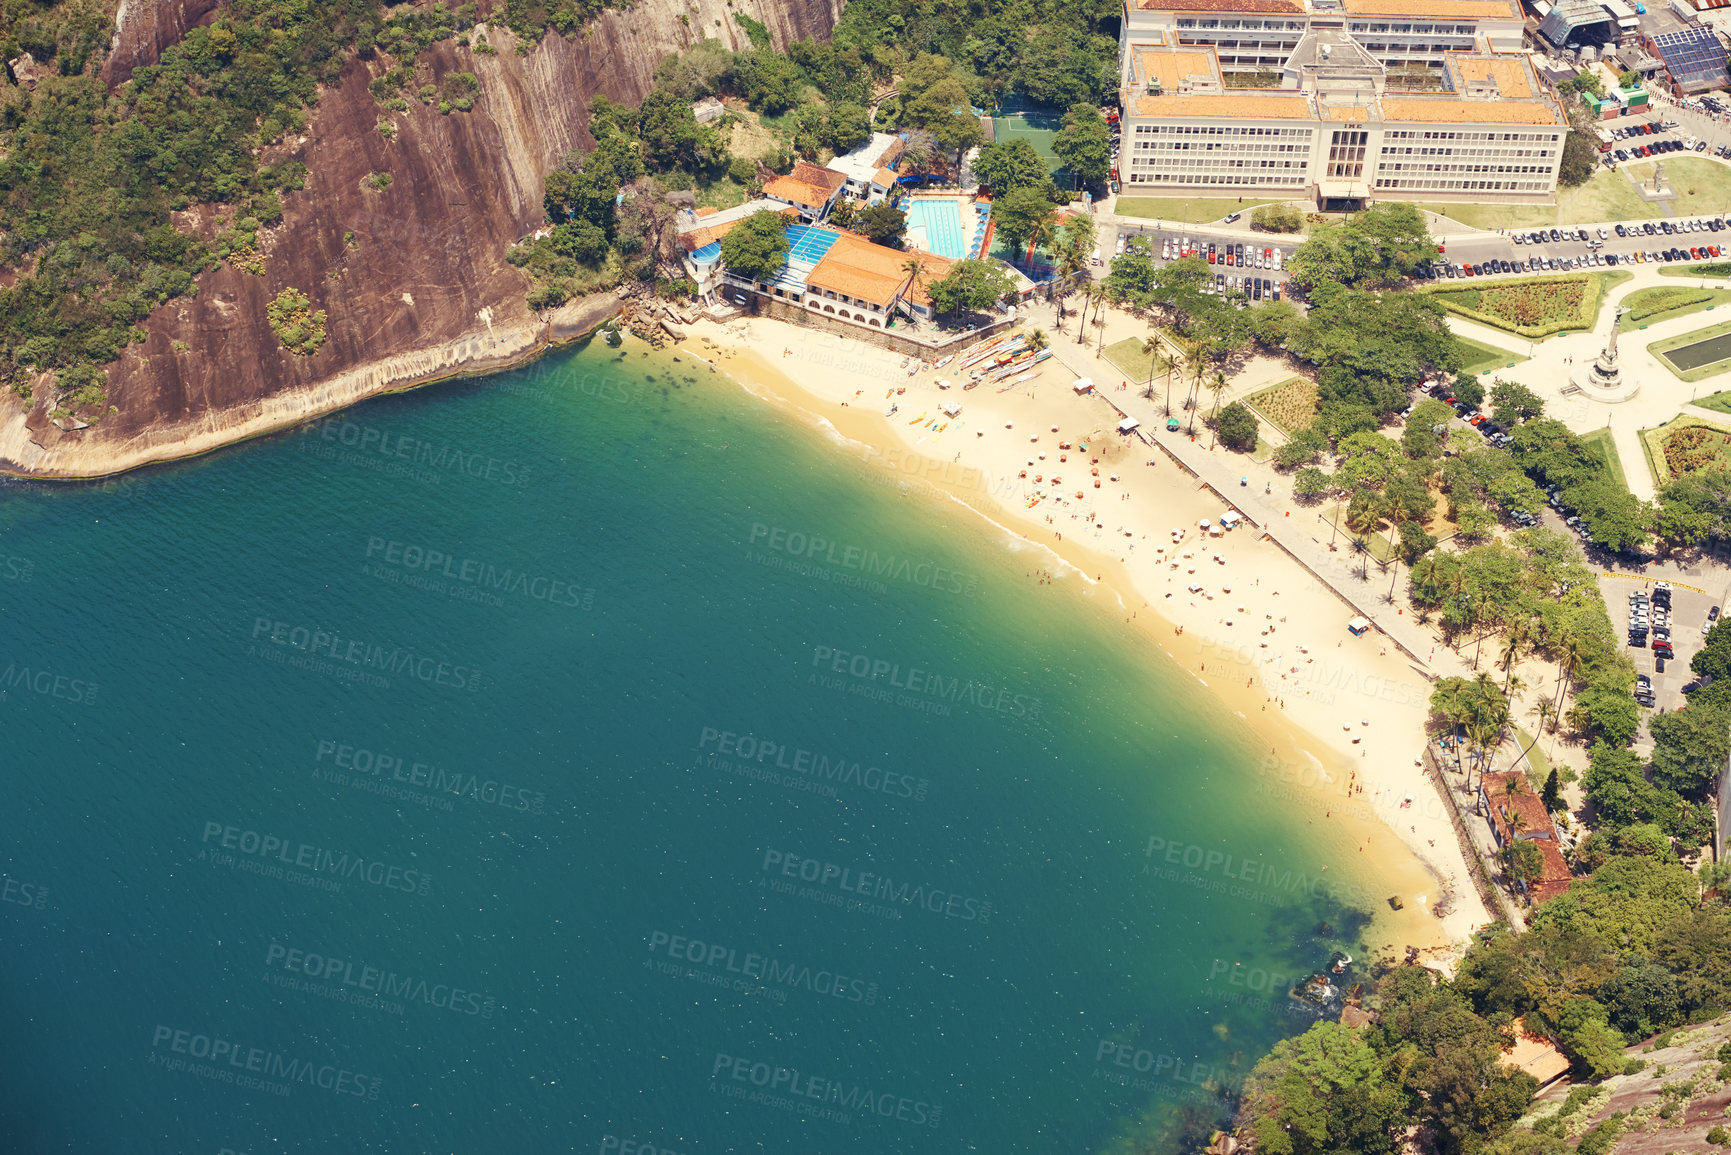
[0,0,384,416]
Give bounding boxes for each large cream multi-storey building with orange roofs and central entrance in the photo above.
[1118,0,1568,204]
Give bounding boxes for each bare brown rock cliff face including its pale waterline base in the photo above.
[0,0,841,476]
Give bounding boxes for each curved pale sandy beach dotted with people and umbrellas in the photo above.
[679,311,1490,965]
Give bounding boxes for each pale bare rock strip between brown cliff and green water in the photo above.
[0,293,621,481]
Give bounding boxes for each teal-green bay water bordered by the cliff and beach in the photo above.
[0,343,1376,1155]
